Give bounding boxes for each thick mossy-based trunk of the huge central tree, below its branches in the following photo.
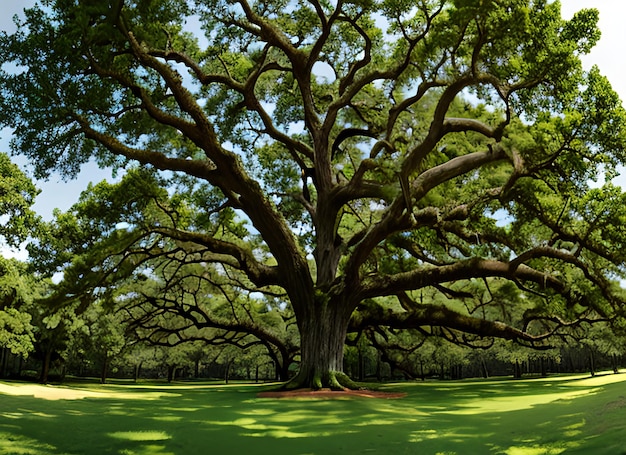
[287,301,357,390]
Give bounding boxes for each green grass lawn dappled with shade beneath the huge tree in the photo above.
[0,374,626,455]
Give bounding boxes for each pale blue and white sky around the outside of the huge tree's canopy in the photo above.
[0,0,626,257]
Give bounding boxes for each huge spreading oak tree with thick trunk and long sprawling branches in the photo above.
[0,0,626,388]
